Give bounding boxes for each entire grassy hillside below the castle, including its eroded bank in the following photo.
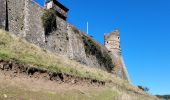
[0,30,157,100]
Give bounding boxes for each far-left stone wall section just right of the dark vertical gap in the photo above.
[7,0,25,35]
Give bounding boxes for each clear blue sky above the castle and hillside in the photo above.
[35,0,170,94]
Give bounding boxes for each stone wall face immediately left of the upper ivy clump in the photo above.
[23,0,45,47]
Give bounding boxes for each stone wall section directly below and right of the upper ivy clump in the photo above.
[45,17,69,55]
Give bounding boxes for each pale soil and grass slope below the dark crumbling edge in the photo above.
[0,72,157,100]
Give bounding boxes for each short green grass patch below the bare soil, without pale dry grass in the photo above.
[0,86,117,100]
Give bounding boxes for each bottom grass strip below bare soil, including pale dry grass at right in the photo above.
[0,84,158,100]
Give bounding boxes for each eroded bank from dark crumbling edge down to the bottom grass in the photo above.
[0,60,157,100]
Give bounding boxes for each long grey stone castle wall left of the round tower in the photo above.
[0,0,129,81]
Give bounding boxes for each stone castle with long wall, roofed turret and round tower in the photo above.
[0,0,130,82]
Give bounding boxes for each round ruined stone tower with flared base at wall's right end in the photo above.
[104,30,130,82]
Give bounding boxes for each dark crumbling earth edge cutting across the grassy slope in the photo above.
[0,60,105,86]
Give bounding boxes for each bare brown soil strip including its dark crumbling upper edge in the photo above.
[0,60,105,92]
